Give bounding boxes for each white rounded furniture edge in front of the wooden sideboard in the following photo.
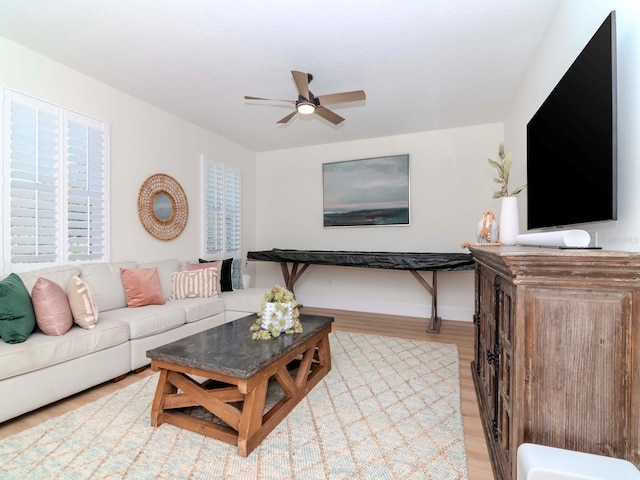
[517,443,640,480]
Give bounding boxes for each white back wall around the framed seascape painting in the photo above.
[255,124,504,321]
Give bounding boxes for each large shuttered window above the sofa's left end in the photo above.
[0,88,109,273]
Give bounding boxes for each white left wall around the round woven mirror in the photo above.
[0,37,256,262]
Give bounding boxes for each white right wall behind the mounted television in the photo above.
[505,0,640,251]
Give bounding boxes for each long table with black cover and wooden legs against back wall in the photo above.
[247,248,474,333]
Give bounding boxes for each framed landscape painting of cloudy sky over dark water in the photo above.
[322,155,410,227]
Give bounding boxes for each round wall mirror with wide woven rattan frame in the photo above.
[138,173,189,240]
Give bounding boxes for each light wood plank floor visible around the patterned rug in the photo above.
[0,307,493,480]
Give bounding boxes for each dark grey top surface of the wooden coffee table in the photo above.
[147,314,333,379]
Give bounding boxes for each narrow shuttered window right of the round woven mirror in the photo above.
[200,155,240,259]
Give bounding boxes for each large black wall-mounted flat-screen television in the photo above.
[526,11,617,229]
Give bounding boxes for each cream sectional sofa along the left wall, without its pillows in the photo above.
[0,259,265,422]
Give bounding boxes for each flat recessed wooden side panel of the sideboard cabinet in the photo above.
[523,288,633,457]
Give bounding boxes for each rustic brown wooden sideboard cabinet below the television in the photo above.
[470,247,640,480]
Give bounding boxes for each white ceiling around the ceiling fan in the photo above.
[0,0,558,151]
